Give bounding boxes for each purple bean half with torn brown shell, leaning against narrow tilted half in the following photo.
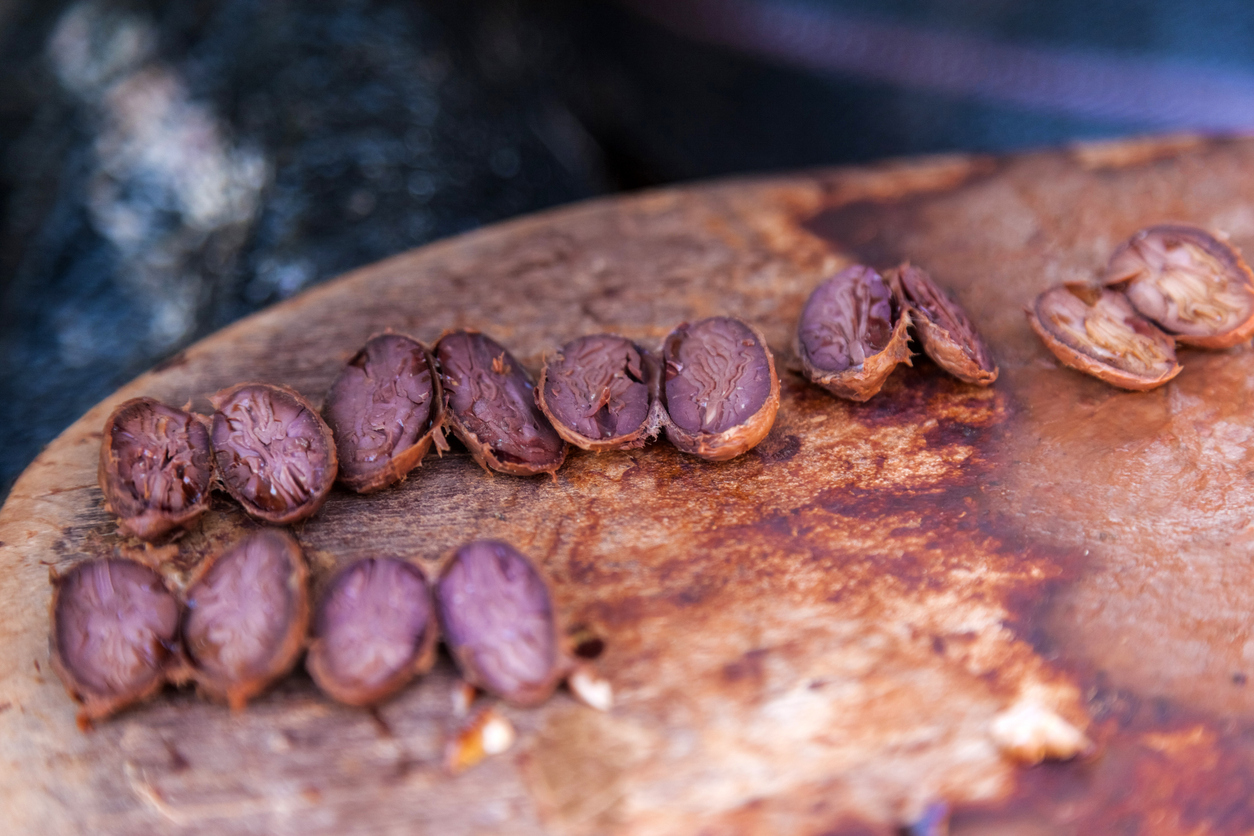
[796,264,912,401]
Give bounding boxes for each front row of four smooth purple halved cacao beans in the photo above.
[50,536,591,726]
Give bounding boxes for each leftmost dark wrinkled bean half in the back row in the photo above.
[97,397,213,540]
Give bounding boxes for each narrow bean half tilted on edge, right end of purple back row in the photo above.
[889,262,997,386]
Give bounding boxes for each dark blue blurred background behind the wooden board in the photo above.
[0,0,1254,498]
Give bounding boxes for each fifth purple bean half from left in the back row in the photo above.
[535,333,661,451]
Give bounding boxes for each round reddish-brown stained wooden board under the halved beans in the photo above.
[0,138,1254,836]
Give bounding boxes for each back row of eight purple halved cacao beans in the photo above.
[99,264,997,540]
